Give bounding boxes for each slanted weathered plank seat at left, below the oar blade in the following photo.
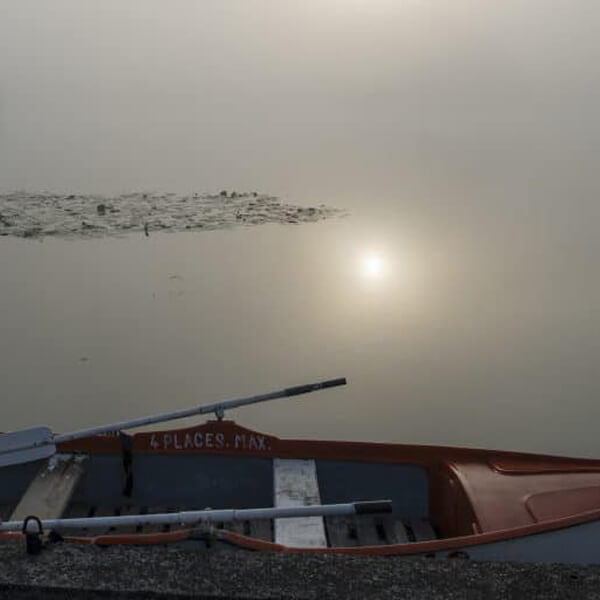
[10,454,87,521]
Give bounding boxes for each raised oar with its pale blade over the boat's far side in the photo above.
[0,377,346,467]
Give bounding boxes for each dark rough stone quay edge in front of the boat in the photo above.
[0,542,600,600]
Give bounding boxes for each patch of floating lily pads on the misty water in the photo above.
[0,191,346,238]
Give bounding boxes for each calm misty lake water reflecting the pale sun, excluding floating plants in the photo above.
[0,0,600,456]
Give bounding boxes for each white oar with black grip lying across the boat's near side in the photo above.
[0,500,392,533]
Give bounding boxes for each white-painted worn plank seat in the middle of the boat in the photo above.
[273,458,327,548]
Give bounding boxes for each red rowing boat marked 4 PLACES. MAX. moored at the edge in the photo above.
[0,414,600,563]
